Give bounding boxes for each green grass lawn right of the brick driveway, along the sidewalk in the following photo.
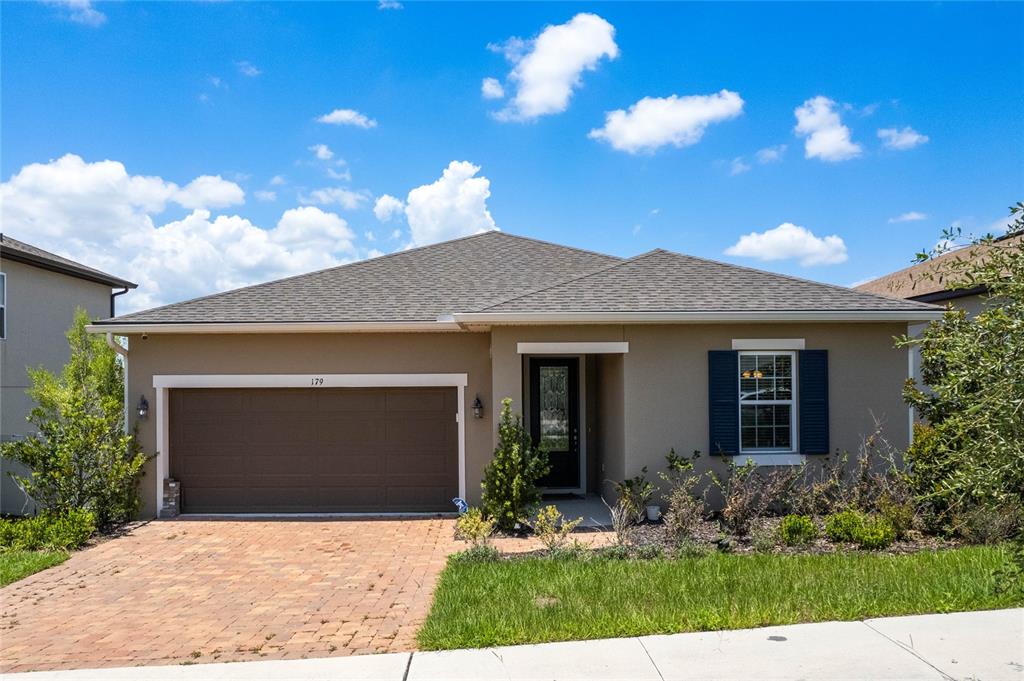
[419,547,1021,650]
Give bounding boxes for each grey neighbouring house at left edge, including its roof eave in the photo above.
[0,233,135,513]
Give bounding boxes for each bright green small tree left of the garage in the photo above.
[2,309,146,529]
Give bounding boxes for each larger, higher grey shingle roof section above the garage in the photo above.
[101,231,620,324]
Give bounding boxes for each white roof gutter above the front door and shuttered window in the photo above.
[447,309,943,324]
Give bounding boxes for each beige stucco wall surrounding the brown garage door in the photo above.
[122,333,494,517]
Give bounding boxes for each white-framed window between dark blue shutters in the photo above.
[737,350,797,454]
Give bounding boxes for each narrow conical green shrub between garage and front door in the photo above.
[480,397,550,533]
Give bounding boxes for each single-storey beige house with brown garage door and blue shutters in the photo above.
[90,231,940,515]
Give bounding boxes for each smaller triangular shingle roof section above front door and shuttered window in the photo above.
[479,249,934,312]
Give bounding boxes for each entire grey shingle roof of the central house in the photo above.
[99,231,936,324]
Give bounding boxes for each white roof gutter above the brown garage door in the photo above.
[85,320,463,336]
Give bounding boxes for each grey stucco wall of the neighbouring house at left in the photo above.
[0,259,111,513]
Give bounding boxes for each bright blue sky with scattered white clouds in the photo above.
[0,0,1024,307]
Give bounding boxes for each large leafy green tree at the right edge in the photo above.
[898,203,1024,514]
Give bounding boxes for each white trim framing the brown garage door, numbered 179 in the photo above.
[153,374,469,514]
